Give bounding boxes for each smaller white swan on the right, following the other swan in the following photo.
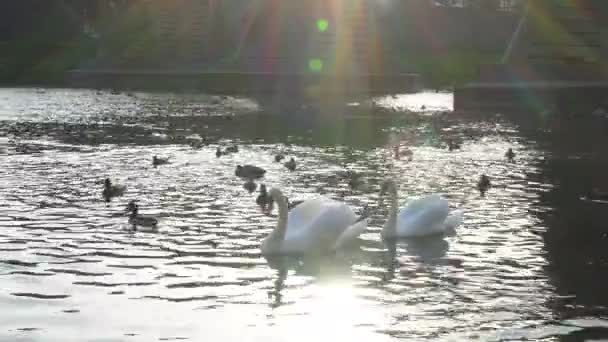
[381,180,463,239]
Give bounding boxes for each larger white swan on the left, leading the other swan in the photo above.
[261,188,367,255]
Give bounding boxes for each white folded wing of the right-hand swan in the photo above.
[397,195,450,237]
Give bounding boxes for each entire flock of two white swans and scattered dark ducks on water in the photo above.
[102,142,515,255]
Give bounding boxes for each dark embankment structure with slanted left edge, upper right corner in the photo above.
[454,0,608,112]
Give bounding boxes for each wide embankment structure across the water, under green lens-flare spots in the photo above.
[70,0,419,96]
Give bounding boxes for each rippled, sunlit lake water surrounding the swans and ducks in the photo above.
[0,89,608,342]
